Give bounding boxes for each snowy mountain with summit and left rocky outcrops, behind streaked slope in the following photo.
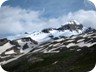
[0,20,83,56]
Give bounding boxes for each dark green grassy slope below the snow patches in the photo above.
[3,46,96,72]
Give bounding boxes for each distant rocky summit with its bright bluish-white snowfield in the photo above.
[7,20,83,42]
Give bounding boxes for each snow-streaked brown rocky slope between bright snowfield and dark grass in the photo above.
[0,27,96,64]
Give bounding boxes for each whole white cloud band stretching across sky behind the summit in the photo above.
[0,7,96,34]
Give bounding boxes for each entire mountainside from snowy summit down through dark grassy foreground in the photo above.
[0,20,96,72]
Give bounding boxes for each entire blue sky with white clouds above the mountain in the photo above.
[0,0,96,37]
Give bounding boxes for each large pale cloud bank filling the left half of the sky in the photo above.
[0,7,45,34]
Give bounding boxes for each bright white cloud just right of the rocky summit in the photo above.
[71,10,96,28]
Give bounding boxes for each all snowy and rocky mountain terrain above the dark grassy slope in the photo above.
[0,20,96,63]
